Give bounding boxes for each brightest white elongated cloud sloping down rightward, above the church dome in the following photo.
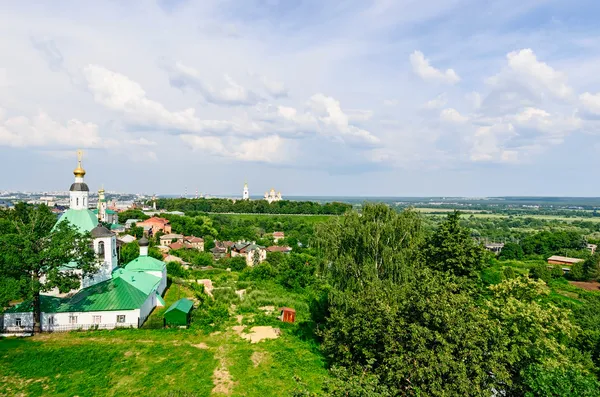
[83,65,231,132]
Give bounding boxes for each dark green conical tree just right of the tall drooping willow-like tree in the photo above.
[425,211,485,278]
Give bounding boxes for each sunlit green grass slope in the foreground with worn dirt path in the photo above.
[0,282,328,397]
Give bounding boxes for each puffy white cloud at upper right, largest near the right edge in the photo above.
[488,48,573,99]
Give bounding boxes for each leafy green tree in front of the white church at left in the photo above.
[0,204,98,332]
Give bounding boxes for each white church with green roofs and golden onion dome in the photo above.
[4,152,167,331]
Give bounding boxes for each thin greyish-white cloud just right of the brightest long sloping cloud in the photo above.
[163,62,262,106]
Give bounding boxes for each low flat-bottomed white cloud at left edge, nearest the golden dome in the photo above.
[0,109,112,148]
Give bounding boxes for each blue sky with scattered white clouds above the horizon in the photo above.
[0,0,600,198]
